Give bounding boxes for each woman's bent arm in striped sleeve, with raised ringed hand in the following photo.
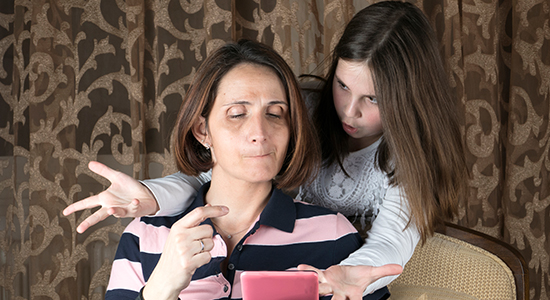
[105,206,228,300]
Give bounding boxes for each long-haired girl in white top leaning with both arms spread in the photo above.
[65,1,468,299]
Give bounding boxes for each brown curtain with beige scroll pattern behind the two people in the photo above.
[0,0,550,299]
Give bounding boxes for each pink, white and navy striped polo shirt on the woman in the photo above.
[105,183,388,300]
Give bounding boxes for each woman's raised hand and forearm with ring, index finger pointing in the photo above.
[143,205,229,299]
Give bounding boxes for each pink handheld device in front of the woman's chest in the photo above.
[241,271,319,300]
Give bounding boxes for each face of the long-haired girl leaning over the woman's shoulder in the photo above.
[332,59,382,151]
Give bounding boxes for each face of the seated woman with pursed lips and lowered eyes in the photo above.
[203,64,290,183]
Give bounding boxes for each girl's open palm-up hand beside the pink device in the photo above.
[298,264,403,300]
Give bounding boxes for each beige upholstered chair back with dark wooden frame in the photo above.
[389,223,529,300]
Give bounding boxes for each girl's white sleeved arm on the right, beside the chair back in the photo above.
[340,187,420,295]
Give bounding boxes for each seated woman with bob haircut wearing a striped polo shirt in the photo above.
[105,41,401,299]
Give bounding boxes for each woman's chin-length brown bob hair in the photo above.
[174,40,321,189]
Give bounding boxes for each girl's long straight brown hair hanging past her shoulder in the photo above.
[315,1,468,241]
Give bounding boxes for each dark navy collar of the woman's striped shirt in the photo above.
[185,182,296,233]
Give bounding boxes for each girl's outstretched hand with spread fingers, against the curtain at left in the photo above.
[63,161,159,233]
